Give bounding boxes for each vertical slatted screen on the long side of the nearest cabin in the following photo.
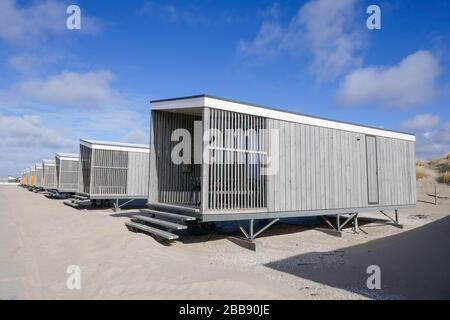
[205,109,266,211]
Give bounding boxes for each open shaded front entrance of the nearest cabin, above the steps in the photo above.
[150,108,202,207]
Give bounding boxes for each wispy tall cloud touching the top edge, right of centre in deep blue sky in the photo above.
[238,0,364,81]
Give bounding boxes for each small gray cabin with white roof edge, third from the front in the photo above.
[55,153,80,194]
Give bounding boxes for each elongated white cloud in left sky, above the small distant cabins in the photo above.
[17,70,120,108]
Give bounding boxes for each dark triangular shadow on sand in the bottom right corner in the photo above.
[266,217,450,299]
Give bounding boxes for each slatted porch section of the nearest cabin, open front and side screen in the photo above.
[149,107,267,212]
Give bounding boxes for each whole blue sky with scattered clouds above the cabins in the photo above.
[0,0,450,176]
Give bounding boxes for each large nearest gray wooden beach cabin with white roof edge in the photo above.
[126,95,416,240]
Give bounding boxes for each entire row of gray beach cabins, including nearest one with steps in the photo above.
[21,95,416,247]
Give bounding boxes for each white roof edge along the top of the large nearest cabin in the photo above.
[152,95,416,141]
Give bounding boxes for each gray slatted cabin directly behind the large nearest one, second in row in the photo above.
[66,140,150,208]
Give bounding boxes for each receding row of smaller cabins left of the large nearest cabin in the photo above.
[21,140,149,209]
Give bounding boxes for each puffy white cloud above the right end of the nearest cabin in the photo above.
[337,51,440,107]
